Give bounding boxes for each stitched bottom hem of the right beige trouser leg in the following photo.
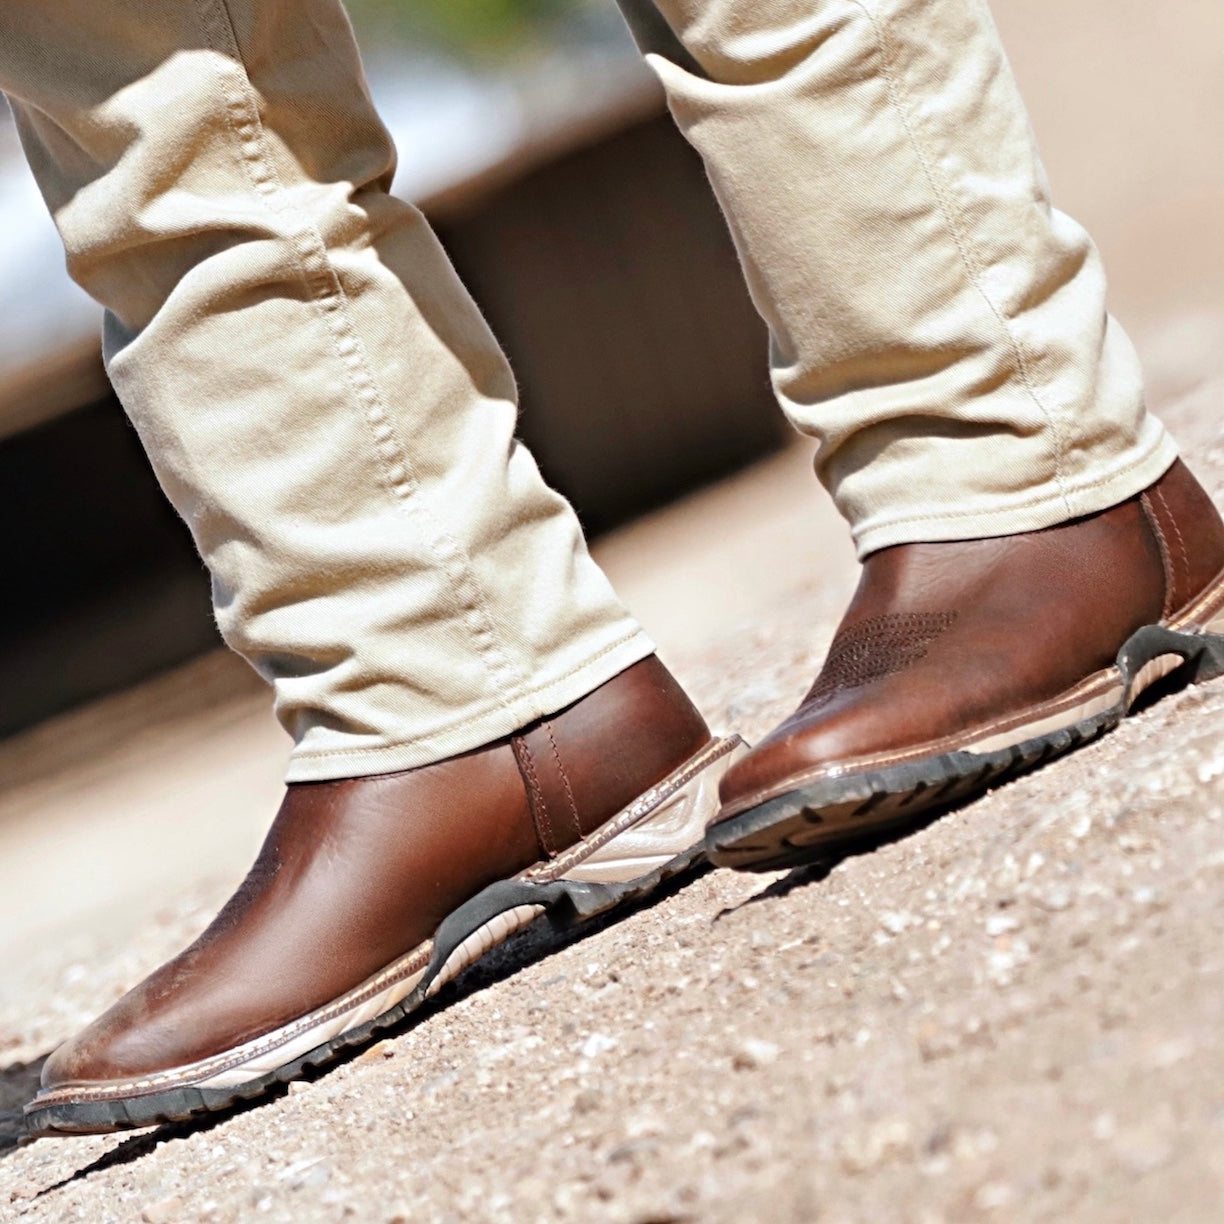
[853,428,1177,550]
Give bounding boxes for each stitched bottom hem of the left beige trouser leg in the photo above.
[285,629,655,782]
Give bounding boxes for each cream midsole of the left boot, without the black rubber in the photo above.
[29,736,747,1109]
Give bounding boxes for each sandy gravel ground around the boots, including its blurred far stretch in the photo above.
[0,0,1224,1209]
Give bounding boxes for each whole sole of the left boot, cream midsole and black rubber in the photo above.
[24,736,747,1138]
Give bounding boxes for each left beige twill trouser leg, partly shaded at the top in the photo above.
[0,0,652,781]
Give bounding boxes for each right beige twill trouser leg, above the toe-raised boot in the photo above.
[622,0,1176,554]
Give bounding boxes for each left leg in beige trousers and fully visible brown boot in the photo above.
[9,0,736,1133]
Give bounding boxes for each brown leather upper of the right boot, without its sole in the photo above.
[717,461,1224,819]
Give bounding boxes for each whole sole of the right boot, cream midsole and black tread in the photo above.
[706,617,1224,871]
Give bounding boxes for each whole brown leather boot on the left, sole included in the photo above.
[26,659,742,1135]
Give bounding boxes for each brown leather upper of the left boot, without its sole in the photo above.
[43,657,710,1088]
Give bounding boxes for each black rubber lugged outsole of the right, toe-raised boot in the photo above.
[705,624,1224,871]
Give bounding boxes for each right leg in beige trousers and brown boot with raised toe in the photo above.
[624,0,1224,867]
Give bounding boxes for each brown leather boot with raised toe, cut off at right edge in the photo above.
[706,461,1224,870]
